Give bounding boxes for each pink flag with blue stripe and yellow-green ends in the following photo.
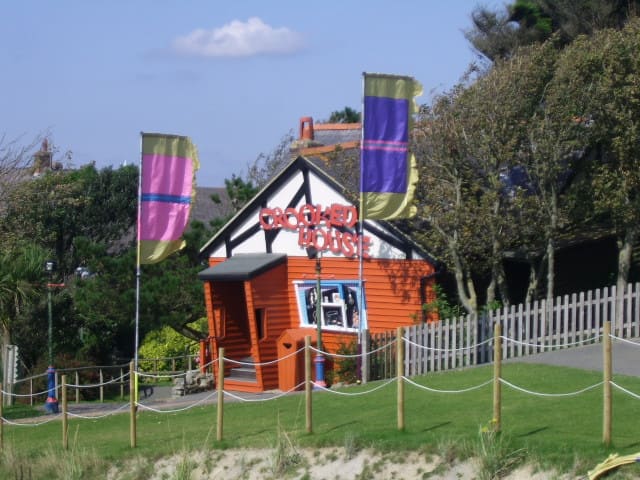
[138,133,200,265]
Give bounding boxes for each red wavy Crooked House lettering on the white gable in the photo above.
[259,203,371,258]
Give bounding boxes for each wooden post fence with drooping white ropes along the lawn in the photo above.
[0,322,640,449]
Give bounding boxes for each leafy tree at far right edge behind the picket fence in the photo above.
[558,19,640,324]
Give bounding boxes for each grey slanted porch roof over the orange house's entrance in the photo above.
[198,253,287,282]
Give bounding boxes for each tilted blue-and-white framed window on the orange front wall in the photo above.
[294,280,366,331]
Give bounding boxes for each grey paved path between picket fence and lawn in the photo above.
[507,338,640,377]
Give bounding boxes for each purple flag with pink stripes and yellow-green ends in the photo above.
[360,73,422,220]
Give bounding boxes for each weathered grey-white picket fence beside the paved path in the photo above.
[404,283,640,376]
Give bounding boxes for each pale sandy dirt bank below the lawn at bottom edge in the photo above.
[109,447,584,480]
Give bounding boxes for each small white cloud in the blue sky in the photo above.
[172,17,304,57]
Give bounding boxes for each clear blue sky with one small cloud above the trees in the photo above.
[0,0,497,186]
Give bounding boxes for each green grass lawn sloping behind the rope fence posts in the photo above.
[0,363,640,478]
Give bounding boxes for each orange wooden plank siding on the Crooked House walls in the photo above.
[205,253,434,391]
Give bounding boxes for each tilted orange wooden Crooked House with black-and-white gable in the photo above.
[199,156,437,392]
